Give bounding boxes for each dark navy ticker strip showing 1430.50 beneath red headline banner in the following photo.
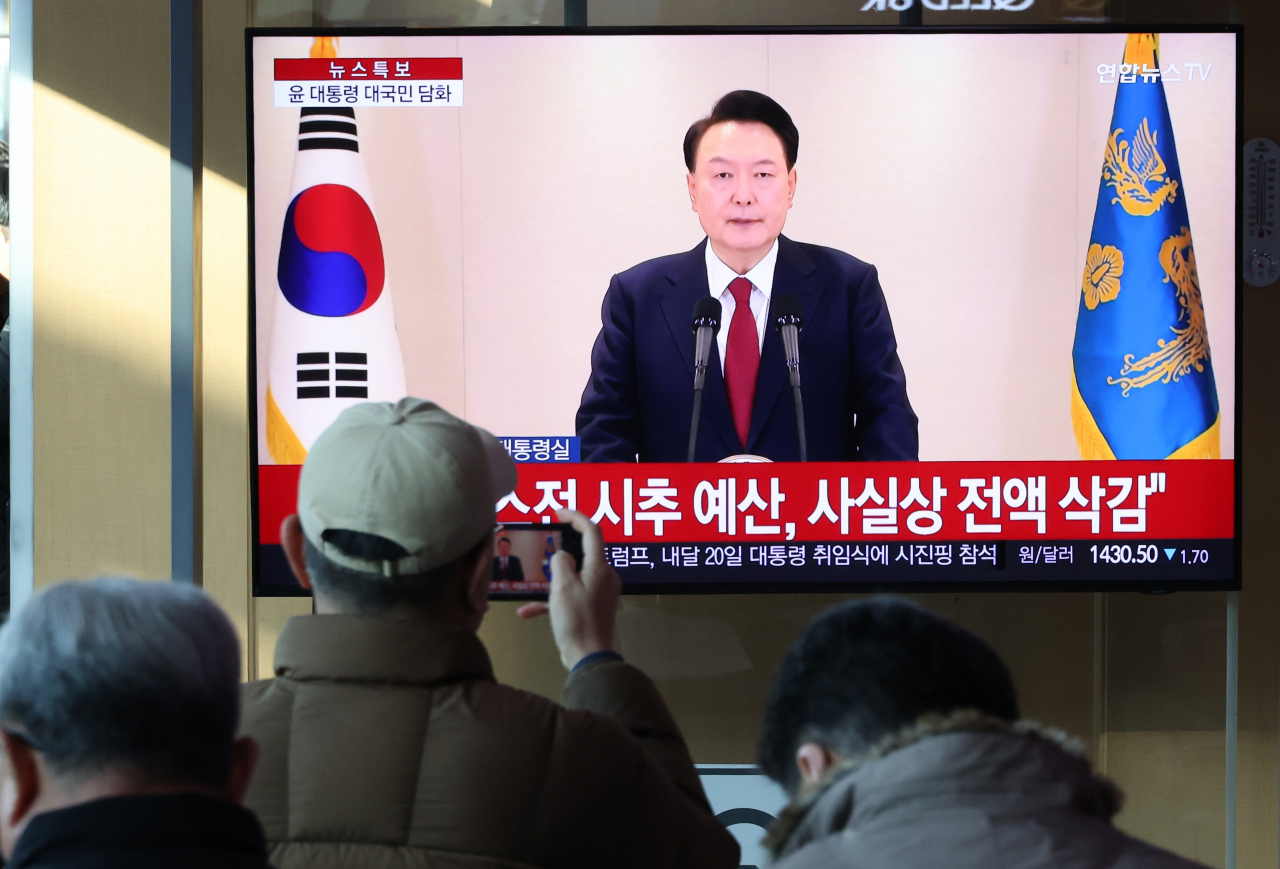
[492,540,1235,594]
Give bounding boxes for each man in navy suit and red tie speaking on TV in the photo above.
[577,91,919,462]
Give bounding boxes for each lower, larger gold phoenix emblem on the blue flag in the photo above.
[1107,227,1208,398]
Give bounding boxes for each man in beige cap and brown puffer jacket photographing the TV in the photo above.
[242,398,737,869]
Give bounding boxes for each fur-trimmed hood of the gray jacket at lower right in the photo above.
[765,709,1124,860]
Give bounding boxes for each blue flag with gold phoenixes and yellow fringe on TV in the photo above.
[1071,33,1220,459]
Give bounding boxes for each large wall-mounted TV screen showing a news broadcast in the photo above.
[248,29,1239,596]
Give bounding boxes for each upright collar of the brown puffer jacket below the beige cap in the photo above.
[275,616,494,686]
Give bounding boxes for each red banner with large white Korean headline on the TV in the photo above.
[259,459,1235,543]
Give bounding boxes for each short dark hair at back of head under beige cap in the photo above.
[303,529,492,616]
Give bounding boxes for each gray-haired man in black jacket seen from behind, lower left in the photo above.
[0,578,268,869]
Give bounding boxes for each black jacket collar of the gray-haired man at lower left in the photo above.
[9,793,266,869]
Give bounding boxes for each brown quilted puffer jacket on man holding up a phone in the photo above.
[241,616,739,869]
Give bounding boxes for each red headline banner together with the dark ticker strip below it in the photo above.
[259,461,1235,583]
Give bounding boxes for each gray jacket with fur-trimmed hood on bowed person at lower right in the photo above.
[769,710,1207,869]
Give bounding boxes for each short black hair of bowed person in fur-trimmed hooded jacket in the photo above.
[760,598,1018,792]
